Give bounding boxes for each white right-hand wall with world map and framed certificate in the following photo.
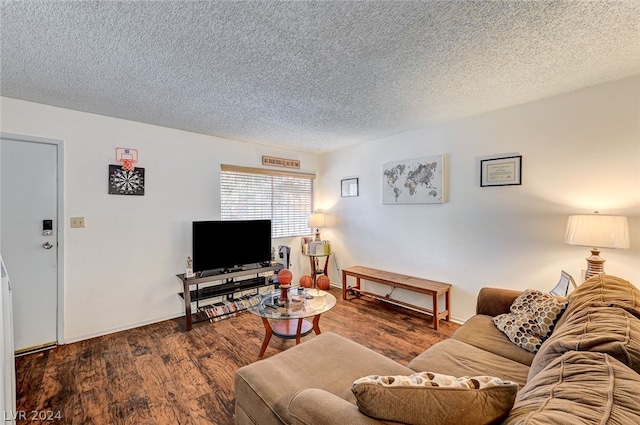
[318,77,640,320]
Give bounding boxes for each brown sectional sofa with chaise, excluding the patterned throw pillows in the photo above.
[235,275,640,425]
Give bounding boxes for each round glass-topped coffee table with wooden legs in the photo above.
[248,287,336,358]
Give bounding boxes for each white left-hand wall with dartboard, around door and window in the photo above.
[0,98,318,342]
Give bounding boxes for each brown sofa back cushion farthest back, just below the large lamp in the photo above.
[556,274,640,326]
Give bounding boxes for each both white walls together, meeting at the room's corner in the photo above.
[0,77,640,342]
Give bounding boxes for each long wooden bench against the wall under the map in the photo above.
[342,266,451,330]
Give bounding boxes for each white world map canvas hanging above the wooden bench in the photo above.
[382,155,445,205]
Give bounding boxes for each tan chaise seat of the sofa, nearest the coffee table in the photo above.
[235,332,413,424]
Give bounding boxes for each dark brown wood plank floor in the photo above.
[16,288,459,425]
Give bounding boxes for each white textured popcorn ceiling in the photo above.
[0,0,640,152]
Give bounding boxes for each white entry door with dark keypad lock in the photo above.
[0,139,58,353]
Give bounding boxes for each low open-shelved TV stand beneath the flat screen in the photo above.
[176,264,284,331]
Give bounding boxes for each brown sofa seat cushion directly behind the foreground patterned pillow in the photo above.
[409,339,529,386]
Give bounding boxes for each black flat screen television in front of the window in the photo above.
[191,220,271,276]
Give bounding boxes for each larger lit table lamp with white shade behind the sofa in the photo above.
[564,211,629,279]
